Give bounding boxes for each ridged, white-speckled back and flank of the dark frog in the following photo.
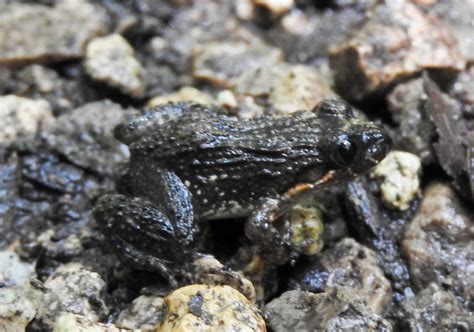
[126,109,321,217]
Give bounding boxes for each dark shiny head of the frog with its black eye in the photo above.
[300,100,393,187]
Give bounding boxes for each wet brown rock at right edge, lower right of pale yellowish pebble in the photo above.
[402,183,474,301]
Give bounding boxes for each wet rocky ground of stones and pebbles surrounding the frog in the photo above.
[0,0,474,331]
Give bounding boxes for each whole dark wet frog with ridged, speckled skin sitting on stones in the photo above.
[94,100,391,281]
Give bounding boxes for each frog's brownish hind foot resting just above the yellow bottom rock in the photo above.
[183,254,256,302]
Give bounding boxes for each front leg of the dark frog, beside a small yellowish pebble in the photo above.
[245,199,293,264]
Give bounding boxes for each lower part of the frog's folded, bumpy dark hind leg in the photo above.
[94,195,193,286]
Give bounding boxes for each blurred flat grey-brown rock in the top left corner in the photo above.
[0,0,106,65]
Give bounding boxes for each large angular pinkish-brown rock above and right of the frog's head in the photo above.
[330,0,465,100]
